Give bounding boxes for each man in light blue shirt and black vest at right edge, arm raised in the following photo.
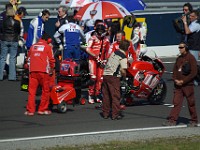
[182,10,200,60]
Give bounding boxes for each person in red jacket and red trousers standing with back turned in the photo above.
[25,33,55,116]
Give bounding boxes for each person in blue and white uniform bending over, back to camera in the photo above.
[54,22,85,60]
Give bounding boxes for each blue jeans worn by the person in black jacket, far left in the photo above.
[0,41,18,80]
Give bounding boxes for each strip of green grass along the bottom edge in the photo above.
[47,136,200,150]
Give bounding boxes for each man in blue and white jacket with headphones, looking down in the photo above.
[26,9,50,49]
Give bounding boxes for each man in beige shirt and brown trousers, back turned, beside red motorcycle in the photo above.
[102,40,130,120]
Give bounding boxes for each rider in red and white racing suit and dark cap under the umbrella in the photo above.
[86,22,110,104]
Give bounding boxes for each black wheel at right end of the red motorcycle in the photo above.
[148,79,167,105]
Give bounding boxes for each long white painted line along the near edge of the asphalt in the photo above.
[0,124,200,143]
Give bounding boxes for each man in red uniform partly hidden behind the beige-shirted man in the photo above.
[107,31,137,60]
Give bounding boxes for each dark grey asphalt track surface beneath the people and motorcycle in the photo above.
[0,58,200,140]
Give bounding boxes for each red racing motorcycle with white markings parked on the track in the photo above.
[121,55,167,104]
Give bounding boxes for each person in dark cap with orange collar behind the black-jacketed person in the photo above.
[15,7,28,47]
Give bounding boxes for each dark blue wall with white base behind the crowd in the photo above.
[21,12,181,57]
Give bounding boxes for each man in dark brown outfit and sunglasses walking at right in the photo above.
[163,42,198,127]
